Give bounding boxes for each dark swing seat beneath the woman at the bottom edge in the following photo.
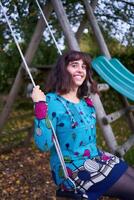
[56,189,87,200]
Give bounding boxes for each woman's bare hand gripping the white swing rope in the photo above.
[31,85,46,103]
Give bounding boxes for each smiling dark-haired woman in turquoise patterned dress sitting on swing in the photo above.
[32,51,134,200]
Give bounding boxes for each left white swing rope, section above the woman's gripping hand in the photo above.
[0,1,35,87]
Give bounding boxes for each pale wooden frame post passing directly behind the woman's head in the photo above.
[51,0,117,152]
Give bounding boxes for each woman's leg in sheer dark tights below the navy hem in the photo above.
[105,167,134,200]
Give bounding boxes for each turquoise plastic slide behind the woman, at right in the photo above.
[92,56,134,100]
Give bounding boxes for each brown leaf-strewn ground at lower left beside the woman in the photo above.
[0,147,118,200]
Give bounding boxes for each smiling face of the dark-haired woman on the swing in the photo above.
[67,59,86,88]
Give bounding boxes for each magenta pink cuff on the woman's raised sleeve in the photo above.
[34,101,48,119]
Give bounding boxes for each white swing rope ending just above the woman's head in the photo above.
[35,0,62,55]
